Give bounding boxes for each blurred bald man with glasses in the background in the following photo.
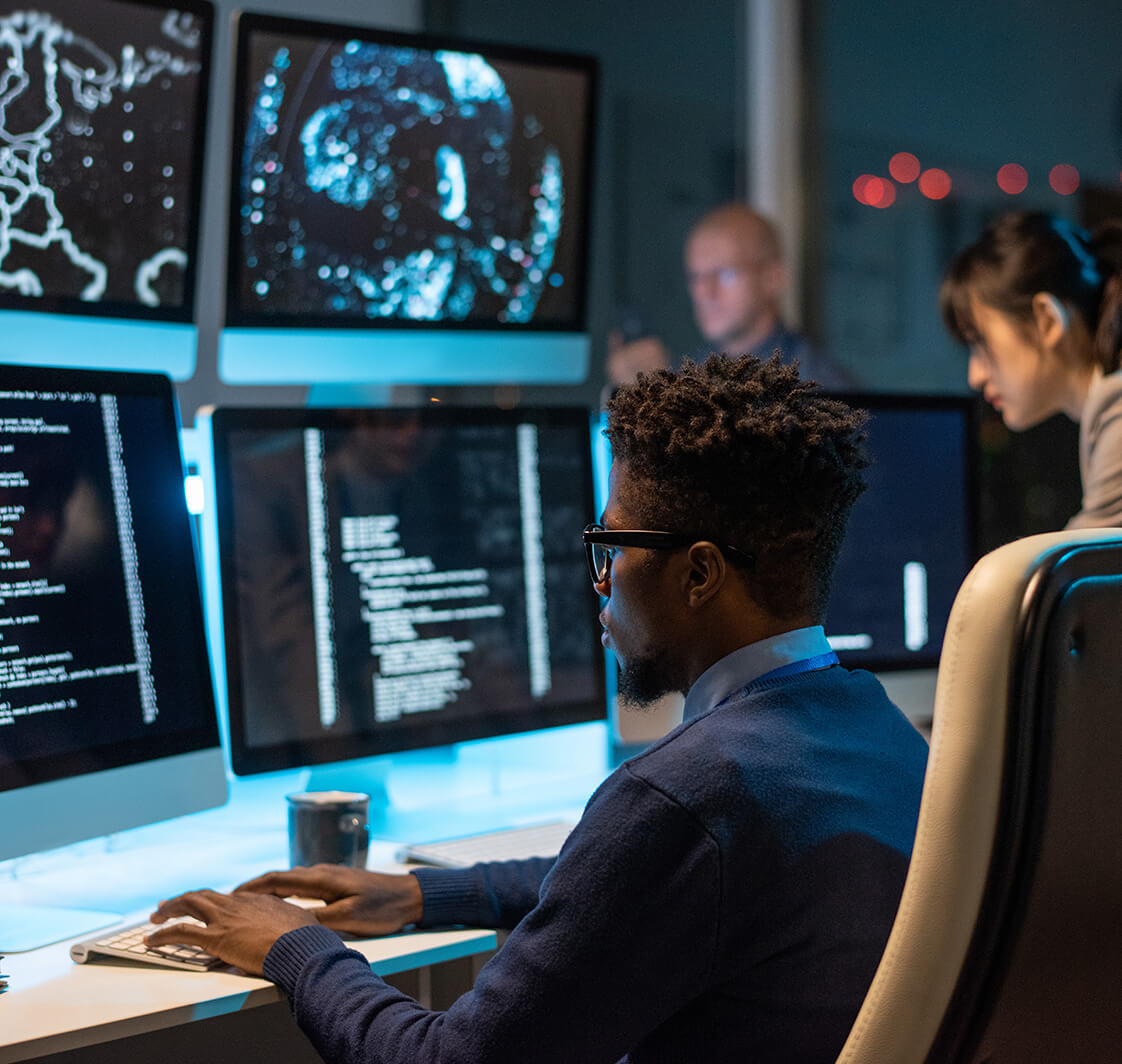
[607,203,854,391]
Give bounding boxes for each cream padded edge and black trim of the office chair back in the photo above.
[838,529,1122,1064]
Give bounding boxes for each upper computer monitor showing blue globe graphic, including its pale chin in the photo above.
[220,13,596,383]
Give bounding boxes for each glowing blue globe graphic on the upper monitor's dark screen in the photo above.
[232,33,587,325]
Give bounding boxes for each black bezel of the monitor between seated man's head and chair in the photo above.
[826,392,981,672]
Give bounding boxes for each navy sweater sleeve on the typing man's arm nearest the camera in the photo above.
[266,765,721,1064]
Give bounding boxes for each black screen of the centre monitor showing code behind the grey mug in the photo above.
[211,405,605,773]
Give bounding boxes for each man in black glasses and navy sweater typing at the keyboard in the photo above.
[150,356,927,1064]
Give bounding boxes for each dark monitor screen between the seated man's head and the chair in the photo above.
[826,394,977,669]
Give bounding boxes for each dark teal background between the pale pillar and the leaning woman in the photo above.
[806,0,1122,391]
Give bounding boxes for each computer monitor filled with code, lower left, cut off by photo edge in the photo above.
[0,365,227,951]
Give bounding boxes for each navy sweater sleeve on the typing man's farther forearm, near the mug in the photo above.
[413,857,553,930]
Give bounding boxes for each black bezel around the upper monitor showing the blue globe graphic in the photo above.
[224,11,599,334]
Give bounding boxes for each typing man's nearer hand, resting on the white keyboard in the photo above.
[147,890,315,975]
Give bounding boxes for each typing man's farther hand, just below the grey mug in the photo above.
[234,864,423,938]
